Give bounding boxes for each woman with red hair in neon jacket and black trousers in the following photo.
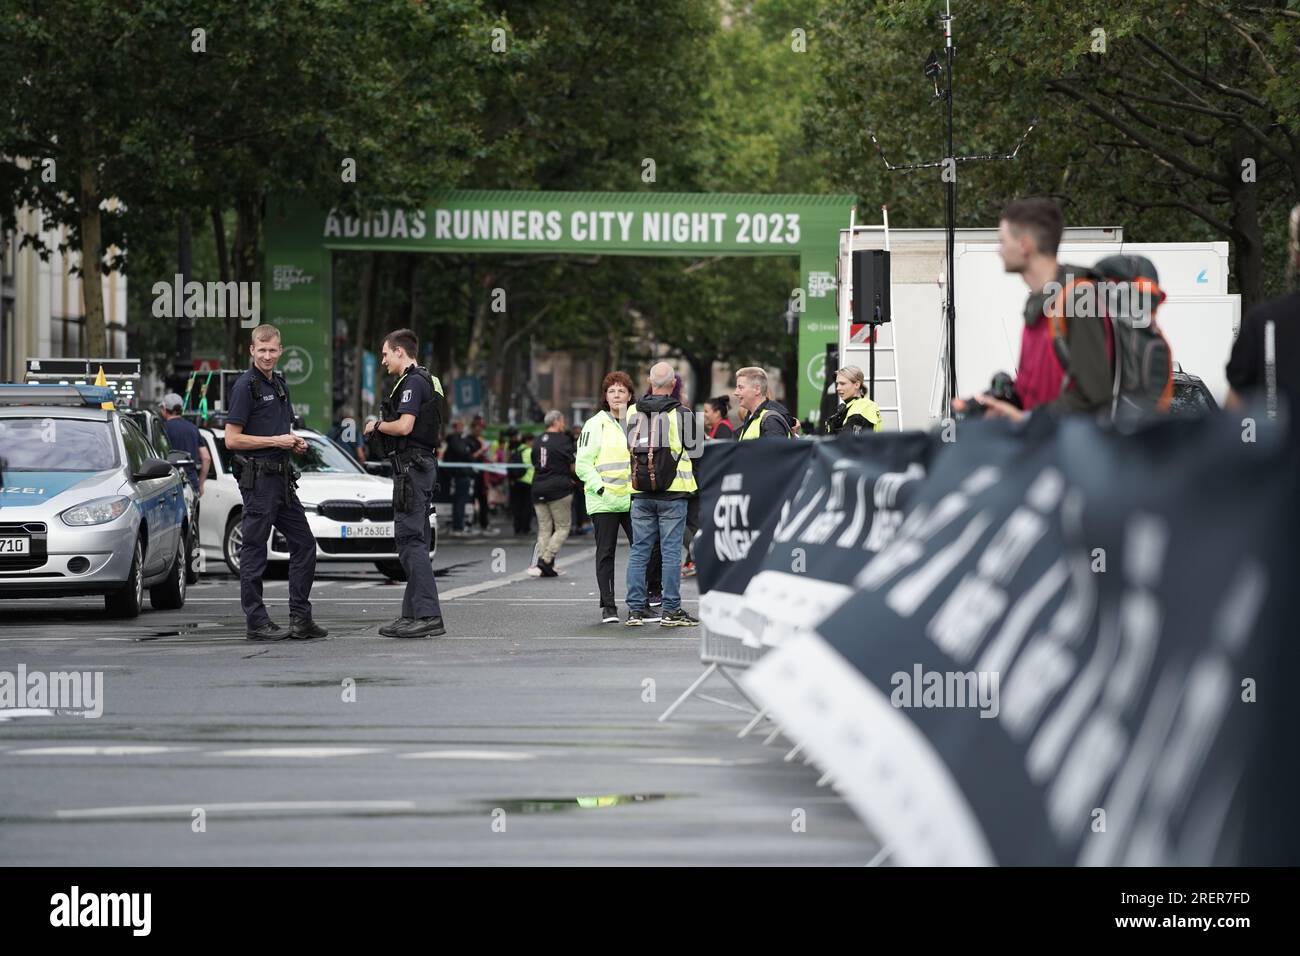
[575,372,632,624]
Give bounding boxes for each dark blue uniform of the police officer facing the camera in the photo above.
[226,367,316,632]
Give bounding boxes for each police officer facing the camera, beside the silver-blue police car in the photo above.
[225,325,329,641]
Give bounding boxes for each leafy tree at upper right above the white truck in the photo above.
[806,0,1300,307]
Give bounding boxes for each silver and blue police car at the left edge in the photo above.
[0,385,190,618]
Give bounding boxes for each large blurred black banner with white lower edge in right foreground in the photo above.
[746,415,1300,865]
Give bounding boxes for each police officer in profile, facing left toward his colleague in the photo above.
[365,329,446,637]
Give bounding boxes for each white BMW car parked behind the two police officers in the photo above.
[199,424,438,581]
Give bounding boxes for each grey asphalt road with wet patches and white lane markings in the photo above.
[0,522,879,866]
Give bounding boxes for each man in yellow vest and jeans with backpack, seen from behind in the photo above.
[624,362,699,627]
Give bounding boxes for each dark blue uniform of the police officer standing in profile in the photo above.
[389,369,442,620]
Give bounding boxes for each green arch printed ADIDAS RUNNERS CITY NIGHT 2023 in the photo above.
[261,191,854,428]
